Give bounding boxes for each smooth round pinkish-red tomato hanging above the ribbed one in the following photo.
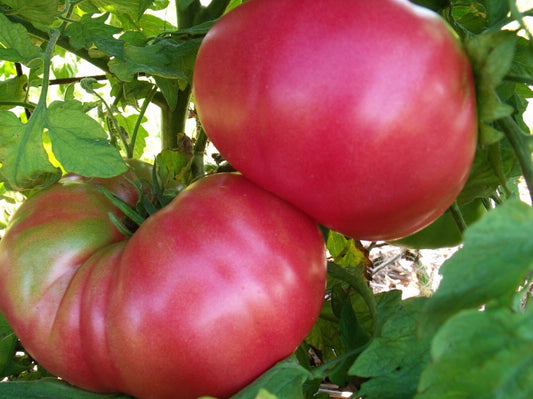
[193,0,477,240]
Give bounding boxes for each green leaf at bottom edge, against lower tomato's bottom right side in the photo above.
[231,360,312,399]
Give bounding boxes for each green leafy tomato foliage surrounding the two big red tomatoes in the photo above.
[0,0,533,399]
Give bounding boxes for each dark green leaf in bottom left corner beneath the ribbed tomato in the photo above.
[0,378,132,399]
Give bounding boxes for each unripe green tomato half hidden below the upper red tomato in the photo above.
[390,199,487,249]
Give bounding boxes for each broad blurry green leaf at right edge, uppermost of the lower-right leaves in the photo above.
[422,200,533,331]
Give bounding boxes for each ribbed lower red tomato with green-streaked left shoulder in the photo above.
[0,174,326,399]
